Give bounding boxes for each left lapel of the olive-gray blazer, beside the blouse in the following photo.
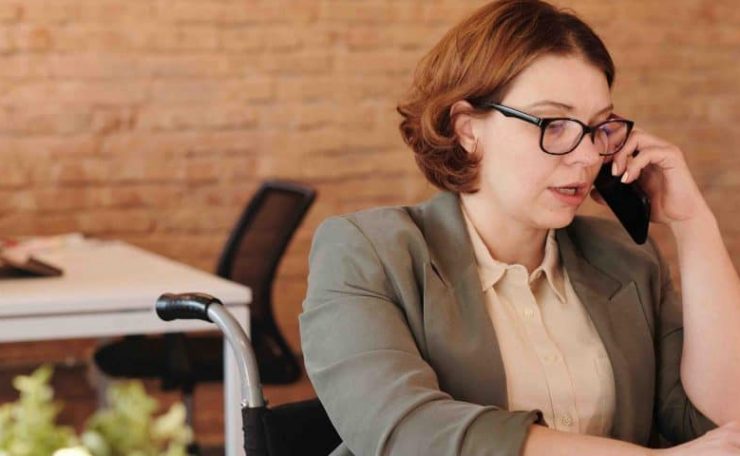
[411,192,508,408]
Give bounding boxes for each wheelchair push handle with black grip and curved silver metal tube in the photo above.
[156,293,265,408]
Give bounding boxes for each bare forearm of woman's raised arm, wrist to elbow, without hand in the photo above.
[671,208,740,424]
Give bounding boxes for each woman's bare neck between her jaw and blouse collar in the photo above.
[460,194,548,273]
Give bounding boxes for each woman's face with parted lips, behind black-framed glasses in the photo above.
[473,55,612,229]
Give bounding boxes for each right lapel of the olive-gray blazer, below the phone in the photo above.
[557,224,655,442]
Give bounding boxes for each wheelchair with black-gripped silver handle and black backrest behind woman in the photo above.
[156,293,341,456]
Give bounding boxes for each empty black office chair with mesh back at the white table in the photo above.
[94,181,316,448]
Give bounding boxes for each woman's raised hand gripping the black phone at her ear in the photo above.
[593,128,709,225]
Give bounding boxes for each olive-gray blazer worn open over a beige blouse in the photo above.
[300,192,715,456]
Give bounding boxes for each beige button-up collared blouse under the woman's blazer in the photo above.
[463,210,615,436]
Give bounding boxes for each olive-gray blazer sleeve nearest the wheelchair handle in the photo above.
[300,218,541,456]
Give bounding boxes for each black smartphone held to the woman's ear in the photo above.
[594,162,650,244]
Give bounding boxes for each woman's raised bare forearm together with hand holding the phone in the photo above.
[613,129,740,425]
